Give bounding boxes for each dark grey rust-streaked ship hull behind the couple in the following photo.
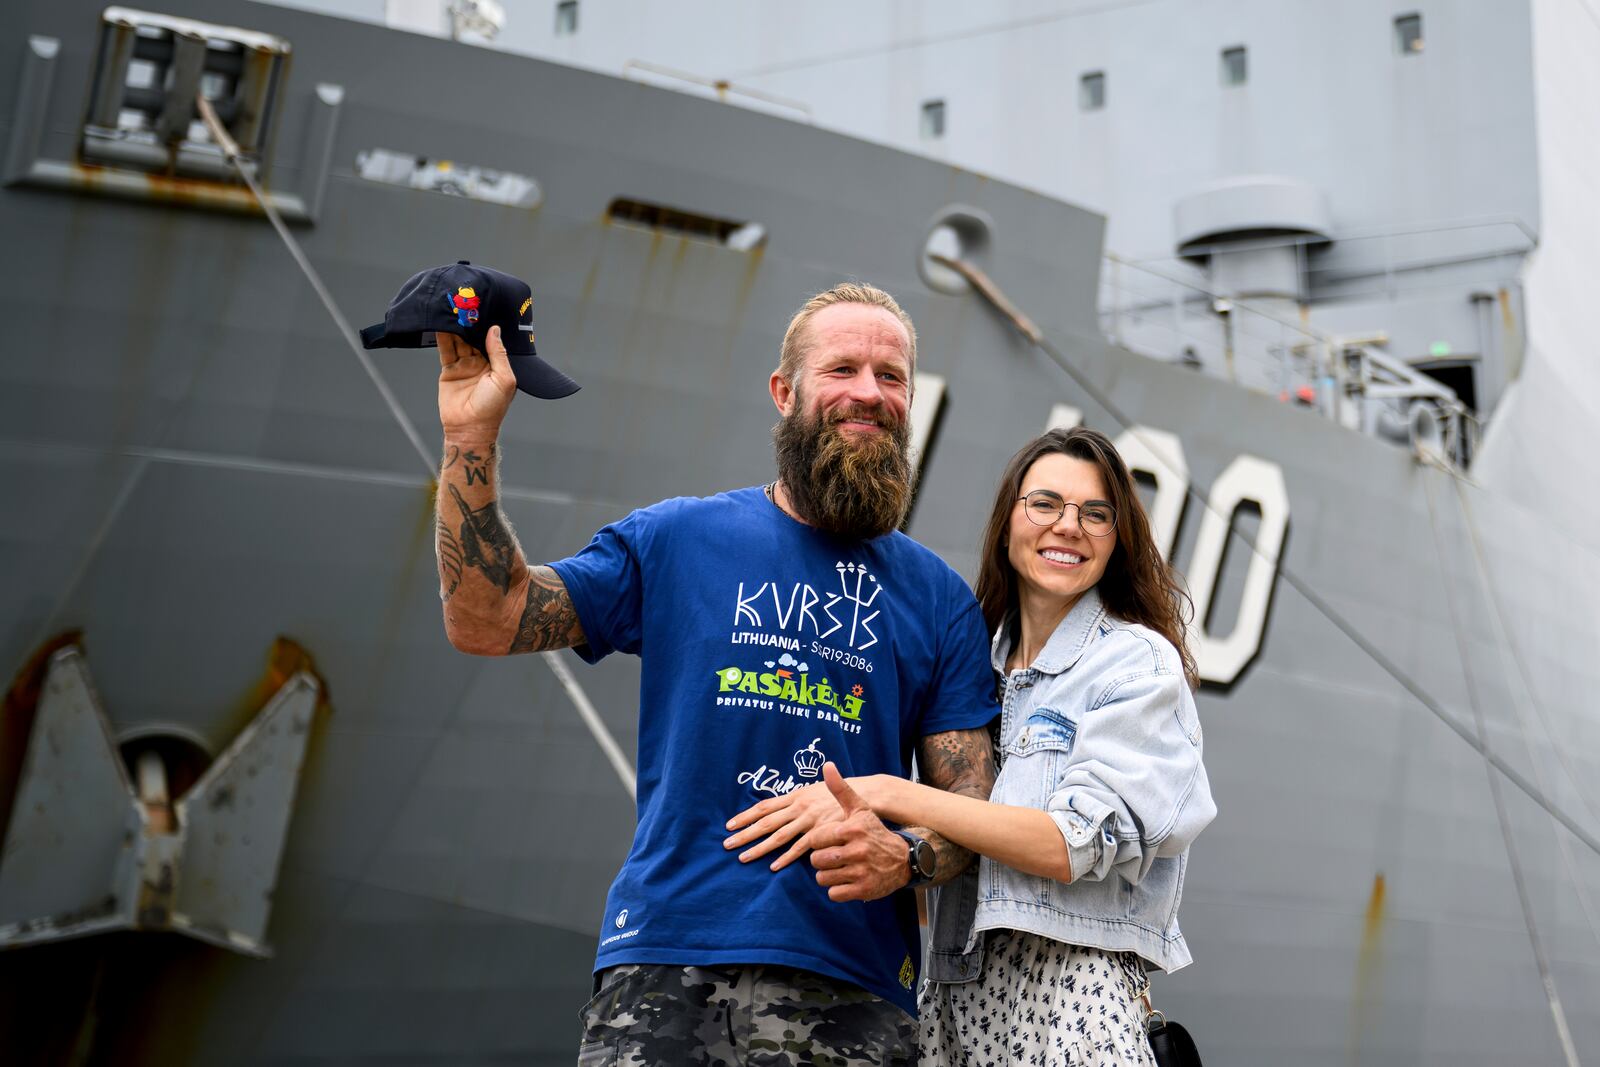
[0,0,1600,1064]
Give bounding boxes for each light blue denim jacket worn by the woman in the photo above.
[926,589,1216,982]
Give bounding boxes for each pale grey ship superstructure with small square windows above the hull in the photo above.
[400,0,1600,479]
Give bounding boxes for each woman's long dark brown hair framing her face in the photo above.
[976,427,1200,689]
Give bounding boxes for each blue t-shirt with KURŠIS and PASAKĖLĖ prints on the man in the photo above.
[552,488,998,1014]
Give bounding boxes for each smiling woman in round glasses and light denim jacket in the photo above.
[915,429,1216,1065]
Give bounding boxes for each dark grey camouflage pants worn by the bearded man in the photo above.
[578,963,917,1067]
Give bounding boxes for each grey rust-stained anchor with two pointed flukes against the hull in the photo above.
[0,648,320,957]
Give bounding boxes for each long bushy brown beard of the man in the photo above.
[773,394,910,541]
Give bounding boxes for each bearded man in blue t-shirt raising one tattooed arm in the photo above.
[438,283,998,1064]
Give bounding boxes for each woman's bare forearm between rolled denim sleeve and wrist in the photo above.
[850,774,1072,881]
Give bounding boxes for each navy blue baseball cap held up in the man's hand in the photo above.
[362,259,578,400]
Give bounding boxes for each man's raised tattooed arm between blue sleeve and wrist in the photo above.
[434,442,584,656]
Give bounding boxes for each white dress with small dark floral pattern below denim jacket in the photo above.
[917,929,1155,1067]
